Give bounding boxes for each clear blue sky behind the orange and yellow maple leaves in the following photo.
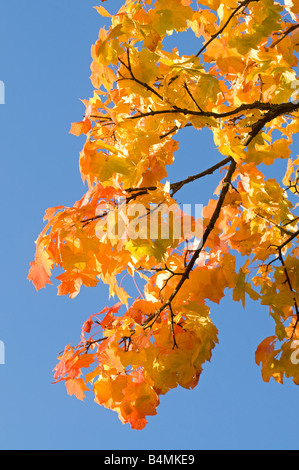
[0,0,299,450]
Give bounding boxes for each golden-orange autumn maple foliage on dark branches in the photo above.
[28,0,299,429]
